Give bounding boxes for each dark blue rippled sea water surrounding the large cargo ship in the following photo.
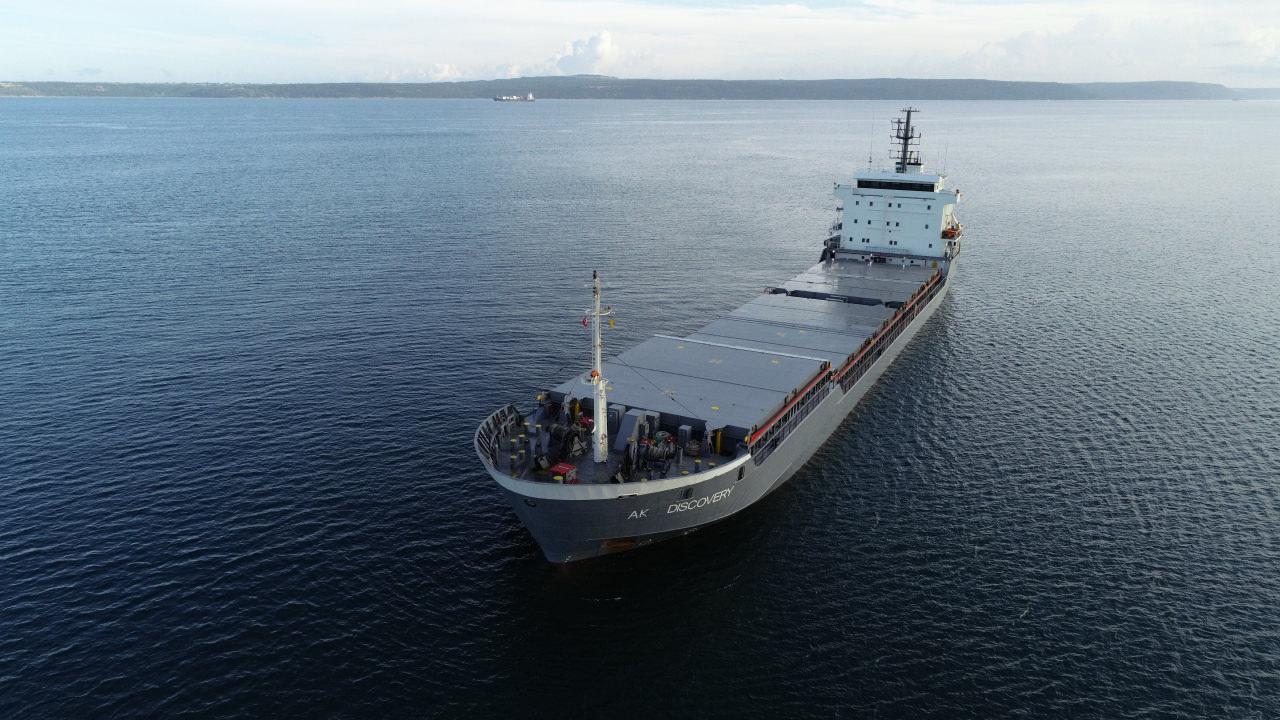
[0,100,1280,719]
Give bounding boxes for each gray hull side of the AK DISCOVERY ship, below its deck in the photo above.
[486,260,955,562]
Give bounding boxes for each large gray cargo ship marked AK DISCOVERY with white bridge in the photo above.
[475,108,964,562]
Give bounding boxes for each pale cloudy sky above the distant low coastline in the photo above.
[0,0,1280,87]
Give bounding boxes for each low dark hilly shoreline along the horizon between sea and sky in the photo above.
[0,76,1280,100]
